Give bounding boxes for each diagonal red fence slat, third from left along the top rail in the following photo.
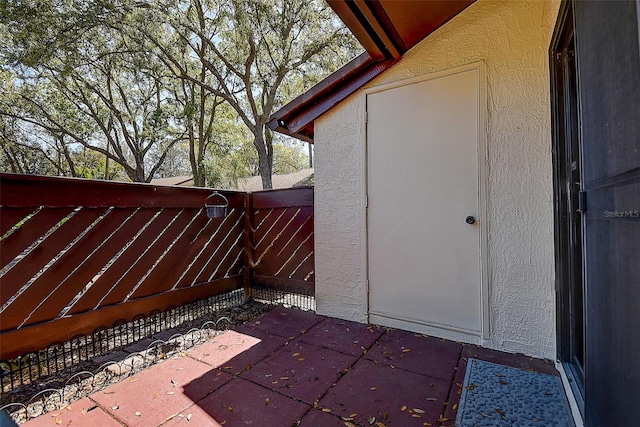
[0,209,105,306]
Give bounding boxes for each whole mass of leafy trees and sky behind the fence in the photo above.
[0,0,359,188]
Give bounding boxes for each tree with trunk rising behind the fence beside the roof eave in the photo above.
[145,0,356,188]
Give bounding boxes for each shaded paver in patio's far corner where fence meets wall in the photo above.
[240,307,325,339]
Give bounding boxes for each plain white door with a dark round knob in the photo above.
[367,67,485,338]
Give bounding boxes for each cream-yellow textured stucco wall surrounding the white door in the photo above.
[315,0,559,359]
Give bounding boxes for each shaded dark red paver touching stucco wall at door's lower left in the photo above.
[299,319,385,356]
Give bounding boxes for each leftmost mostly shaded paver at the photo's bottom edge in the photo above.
[189,378,309,427]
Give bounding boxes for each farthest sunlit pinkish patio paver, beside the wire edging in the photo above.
[187,331,260,368]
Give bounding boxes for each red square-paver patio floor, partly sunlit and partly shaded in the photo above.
[25,308,558,427]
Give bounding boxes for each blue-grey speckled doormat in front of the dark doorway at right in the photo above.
[456,359,574,427]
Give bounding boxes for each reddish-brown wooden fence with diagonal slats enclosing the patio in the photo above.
[0,174,313,360]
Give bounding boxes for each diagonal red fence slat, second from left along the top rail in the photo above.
[0,208,73,268]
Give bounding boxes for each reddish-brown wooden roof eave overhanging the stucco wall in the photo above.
[269,0,476,142]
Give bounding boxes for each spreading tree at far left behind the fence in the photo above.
[0,1,186,182]
